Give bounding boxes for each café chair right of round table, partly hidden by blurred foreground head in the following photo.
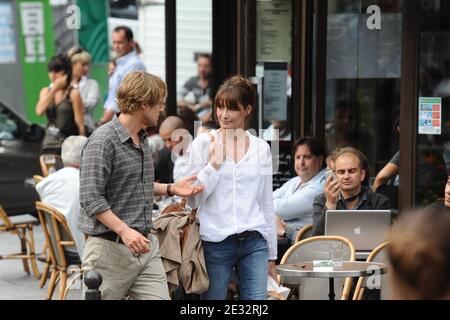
[353,242,390,300]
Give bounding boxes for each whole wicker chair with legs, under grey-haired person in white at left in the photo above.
[36,201,81,300]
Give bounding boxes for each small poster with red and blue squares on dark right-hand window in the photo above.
[419,97,442,135]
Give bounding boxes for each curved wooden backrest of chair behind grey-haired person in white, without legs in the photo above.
[36,201,75,268]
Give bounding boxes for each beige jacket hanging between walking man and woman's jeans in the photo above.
[153,212,209,294]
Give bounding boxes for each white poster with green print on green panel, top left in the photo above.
[20,2,46,63]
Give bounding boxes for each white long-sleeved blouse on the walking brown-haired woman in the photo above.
[188,130,277,260]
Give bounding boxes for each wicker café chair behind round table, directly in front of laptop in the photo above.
[279,236,355,300]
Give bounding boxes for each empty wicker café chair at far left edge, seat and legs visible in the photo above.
[0,206,39,279]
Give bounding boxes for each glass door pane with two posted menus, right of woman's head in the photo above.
[255,0,302,190]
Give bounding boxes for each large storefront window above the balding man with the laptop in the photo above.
[325,0,402,196]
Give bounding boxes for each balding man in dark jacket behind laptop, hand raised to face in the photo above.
[313,148,390,236]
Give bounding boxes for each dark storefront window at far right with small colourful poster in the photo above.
[416,0,450,205]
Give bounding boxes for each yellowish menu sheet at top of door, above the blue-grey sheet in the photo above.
[256,0,292,62]
